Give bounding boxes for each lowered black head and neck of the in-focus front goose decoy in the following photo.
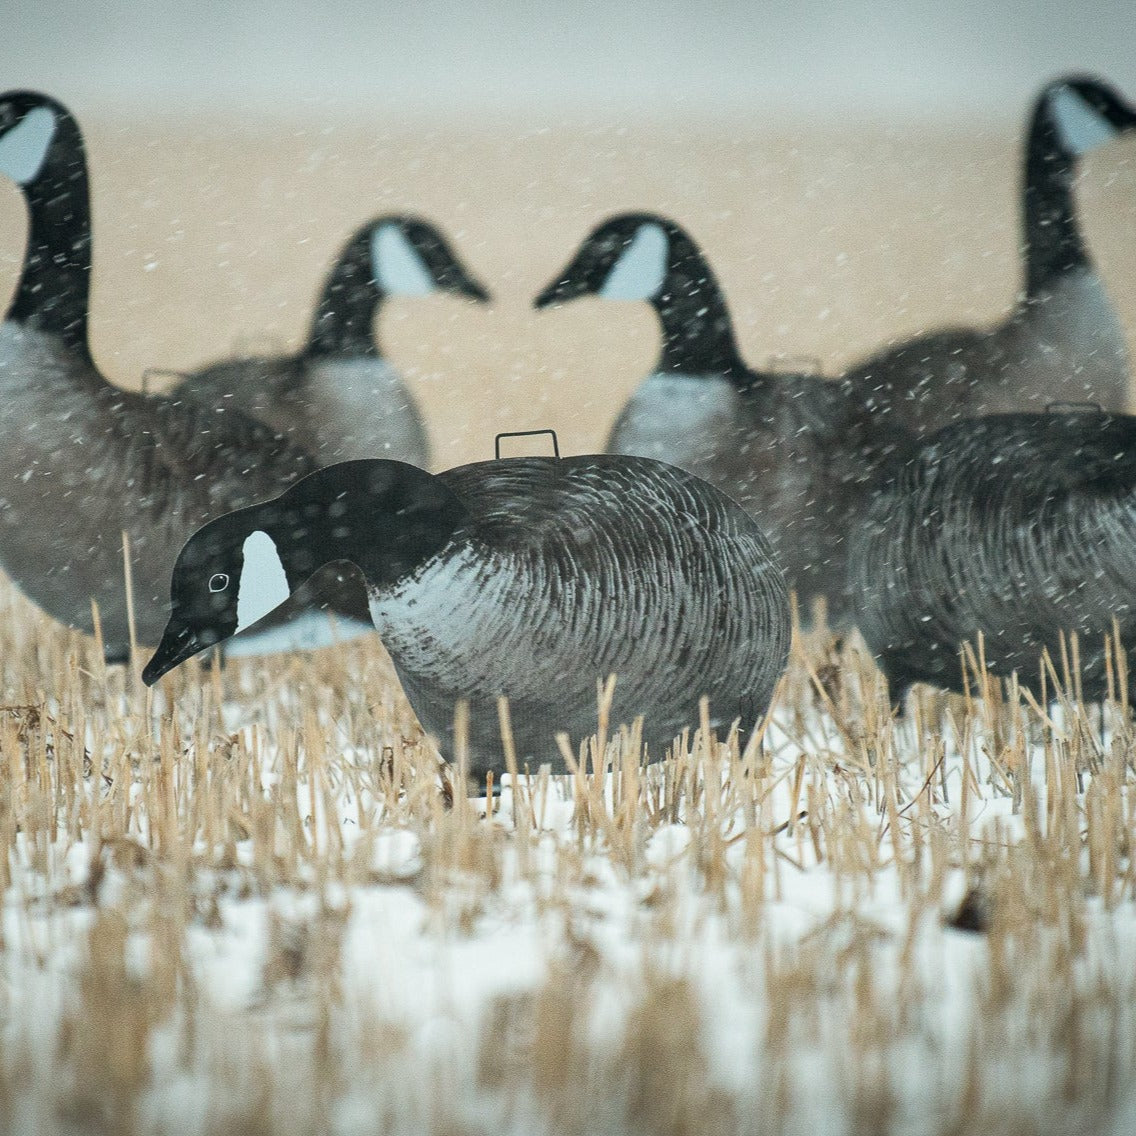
[142,459,465,685]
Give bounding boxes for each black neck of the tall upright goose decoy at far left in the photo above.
[7,103,91,357]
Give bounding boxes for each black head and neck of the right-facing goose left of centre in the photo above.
[309,215,491,354]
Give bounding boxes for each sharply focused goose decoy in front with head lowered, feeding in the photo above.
[143,456,790,775]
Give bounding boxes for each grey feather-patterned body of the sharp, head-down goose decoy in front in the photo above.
[370,457,788,770]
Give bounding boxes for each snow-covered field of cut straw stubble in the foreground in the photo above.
[0,590,1136,1136]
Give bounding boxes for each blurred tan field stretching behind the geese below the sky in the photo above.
[0,113,1136,468]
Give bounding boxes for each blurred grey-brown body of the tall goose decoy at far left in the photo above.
[0,323,316,661]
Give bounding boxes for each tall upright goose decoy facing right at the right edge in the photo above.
[846,76,1136,434]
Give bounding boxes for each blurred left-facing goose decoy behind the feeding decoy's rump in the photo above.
[534,212,896,628]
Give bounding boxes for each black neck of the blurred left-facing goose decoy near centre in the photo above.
[651,226,749,385]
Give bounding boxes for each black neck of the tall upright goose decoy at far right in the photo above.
[1022,97,1091,299]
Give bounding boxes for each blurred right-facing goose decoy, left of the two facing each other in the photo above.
[176,215,490,467]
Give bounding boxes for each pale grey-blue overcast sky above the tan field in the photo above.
[0,0,1136,118]
